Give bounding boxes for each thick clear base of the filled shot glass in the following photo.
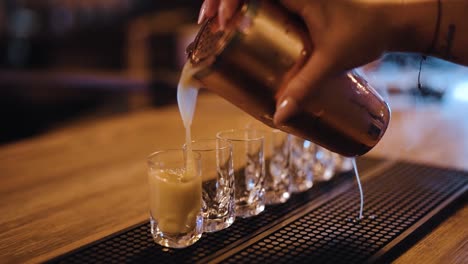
[150,218,203,248]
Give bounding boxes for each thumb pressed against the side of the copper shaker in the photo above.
[273,50,333,125]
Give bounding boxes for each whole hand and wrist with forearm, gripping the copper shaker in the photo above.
[199,0,468,125]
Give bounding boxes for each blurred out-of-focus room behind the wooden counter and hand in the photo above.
[0,0,468,144]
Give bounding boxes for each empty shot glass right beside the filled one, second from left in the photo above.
[187,139,236,232]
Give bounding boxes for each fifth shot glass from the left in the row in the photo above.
[289,136,315,193]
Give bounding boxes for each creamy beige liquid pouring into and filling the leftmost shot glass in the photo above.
[150,63,202,233]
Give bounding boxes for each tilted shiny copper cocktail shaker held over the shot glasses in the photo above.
[188,0,390,156]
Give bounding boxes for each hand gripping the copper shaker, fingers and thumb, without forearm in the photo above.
[198,0,401,124]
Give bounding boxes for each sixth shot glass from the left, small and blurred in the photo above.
[312,145,336,181]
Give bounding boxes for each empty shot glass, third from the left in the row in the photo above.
[216,129,265,218]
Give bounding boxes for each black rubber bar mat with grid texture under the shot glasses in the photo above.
[49,158,468,264]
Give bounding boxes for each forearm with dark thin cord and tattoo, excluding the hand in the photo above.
[392,0,468,65]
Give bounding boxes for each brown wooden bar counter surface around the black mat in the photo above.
[0,93,468,263]
